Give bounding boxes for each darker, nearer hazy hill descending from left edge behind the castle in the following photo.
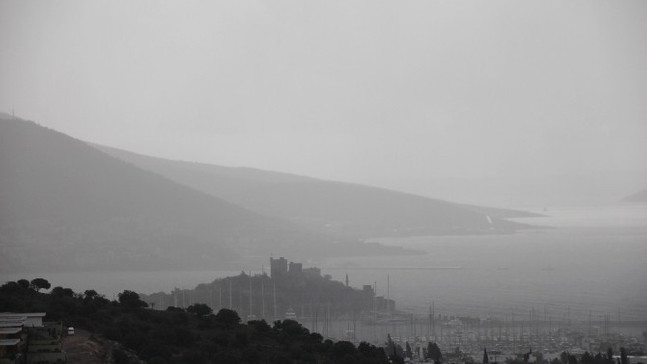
[0,118,398,271]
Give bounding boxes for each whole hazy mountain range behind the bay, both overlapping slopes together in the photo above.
[0,115,536,271]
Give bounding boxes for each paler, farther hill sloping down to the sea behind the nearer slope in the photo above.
[96,146,533,238]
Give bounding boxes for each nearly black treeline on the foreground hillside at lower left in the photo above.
[0,279,389,364]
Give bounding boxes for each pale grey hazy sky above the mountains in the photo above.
[0,0,647,206]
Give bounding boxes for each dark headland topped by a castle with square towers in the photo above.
[143,257,395,320]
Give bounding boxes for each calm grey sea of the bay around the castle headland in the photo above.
[0,205,647,321]
